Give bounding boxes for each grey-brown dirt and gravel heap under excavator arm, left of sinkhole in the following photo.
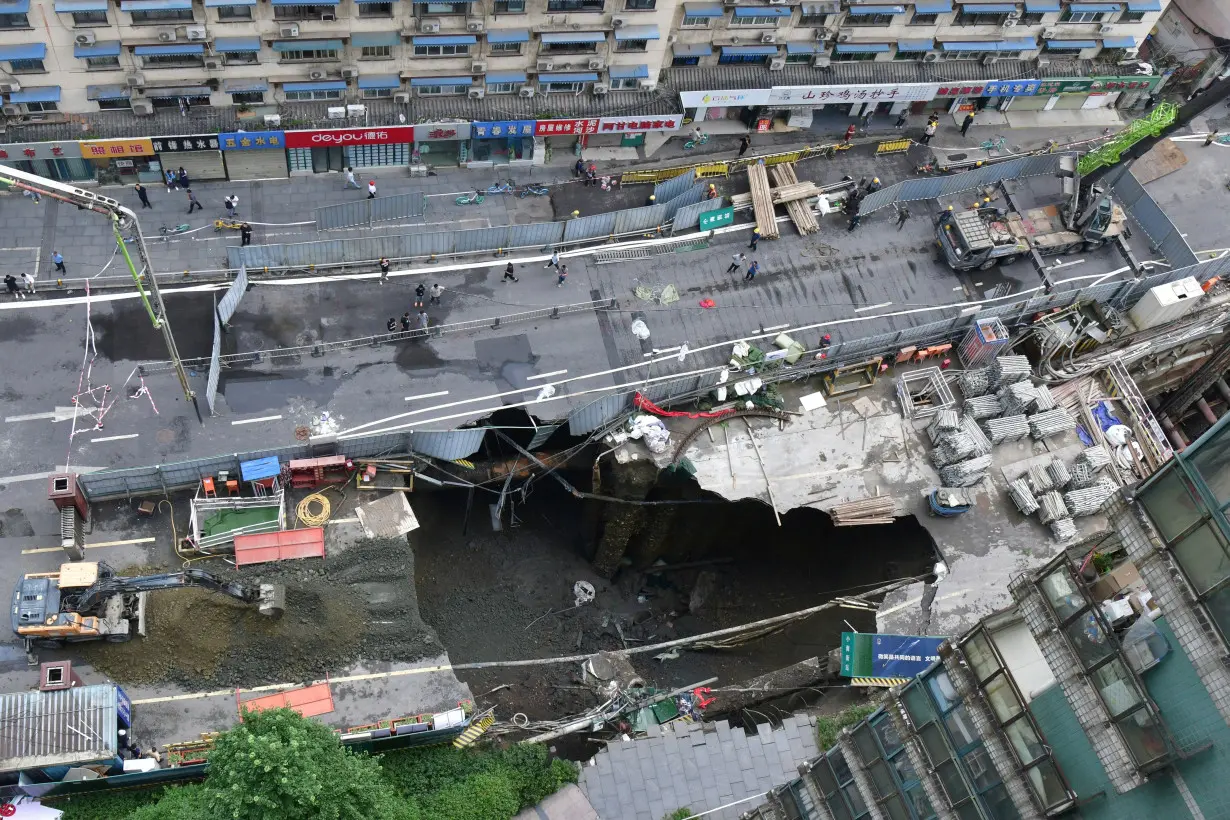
[80,538,440,688]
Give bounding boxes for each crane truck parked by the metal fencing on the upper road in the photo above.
[935,157,1128,270]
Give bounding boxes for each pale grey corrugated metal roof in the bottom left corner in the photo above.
[0,684,118,772]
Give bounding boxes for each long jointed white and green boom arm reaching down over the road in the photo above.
[0,167,204,424]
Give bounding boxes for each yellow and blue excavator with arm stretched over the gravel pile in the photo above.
[12,561,287,647]
